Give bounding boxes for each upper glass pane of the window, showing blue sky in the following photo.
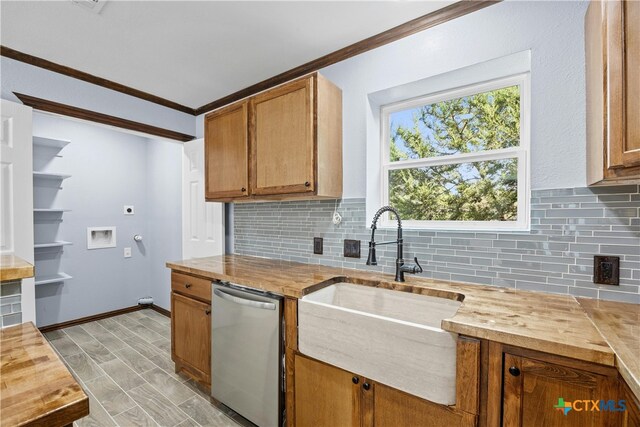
[388,86,520,162]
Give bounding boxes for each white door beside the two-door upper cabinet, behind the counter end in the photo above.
[182,139,224,259]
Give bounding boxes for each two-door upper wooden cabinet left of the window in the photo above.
[205,73,342,201]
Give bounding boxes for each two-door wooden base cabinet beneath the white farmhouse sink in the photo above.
[295,354,477,427]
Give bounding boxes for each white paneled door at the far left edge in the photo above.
[0,99,36,323]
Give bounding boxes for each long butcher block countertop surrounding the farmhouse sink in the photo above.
[167,255,640,398]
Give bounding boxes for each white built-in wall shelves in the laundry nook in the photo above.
[33,136,72,286]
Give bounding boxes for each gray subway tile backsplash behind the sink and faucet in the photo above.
[234,185,640,303]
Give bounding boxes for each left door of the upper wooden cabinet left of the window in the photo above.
[204,101,249,199]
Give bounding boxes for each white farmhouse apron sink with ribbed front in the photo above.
[298,282,461,405]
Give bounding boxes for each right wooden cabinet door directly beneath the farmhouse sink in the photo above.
[373,383,477,427]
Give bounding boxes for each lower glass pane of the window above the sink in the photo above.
[389,158,518,221]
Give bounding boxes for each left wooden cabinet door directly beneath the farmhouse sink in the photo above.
[294,354,363,427]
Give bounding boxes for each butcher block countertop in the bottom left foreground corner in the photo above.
[0,323,89,427]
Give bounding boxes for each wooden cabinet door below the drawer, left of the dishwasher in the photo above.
[171,292,211,383]
